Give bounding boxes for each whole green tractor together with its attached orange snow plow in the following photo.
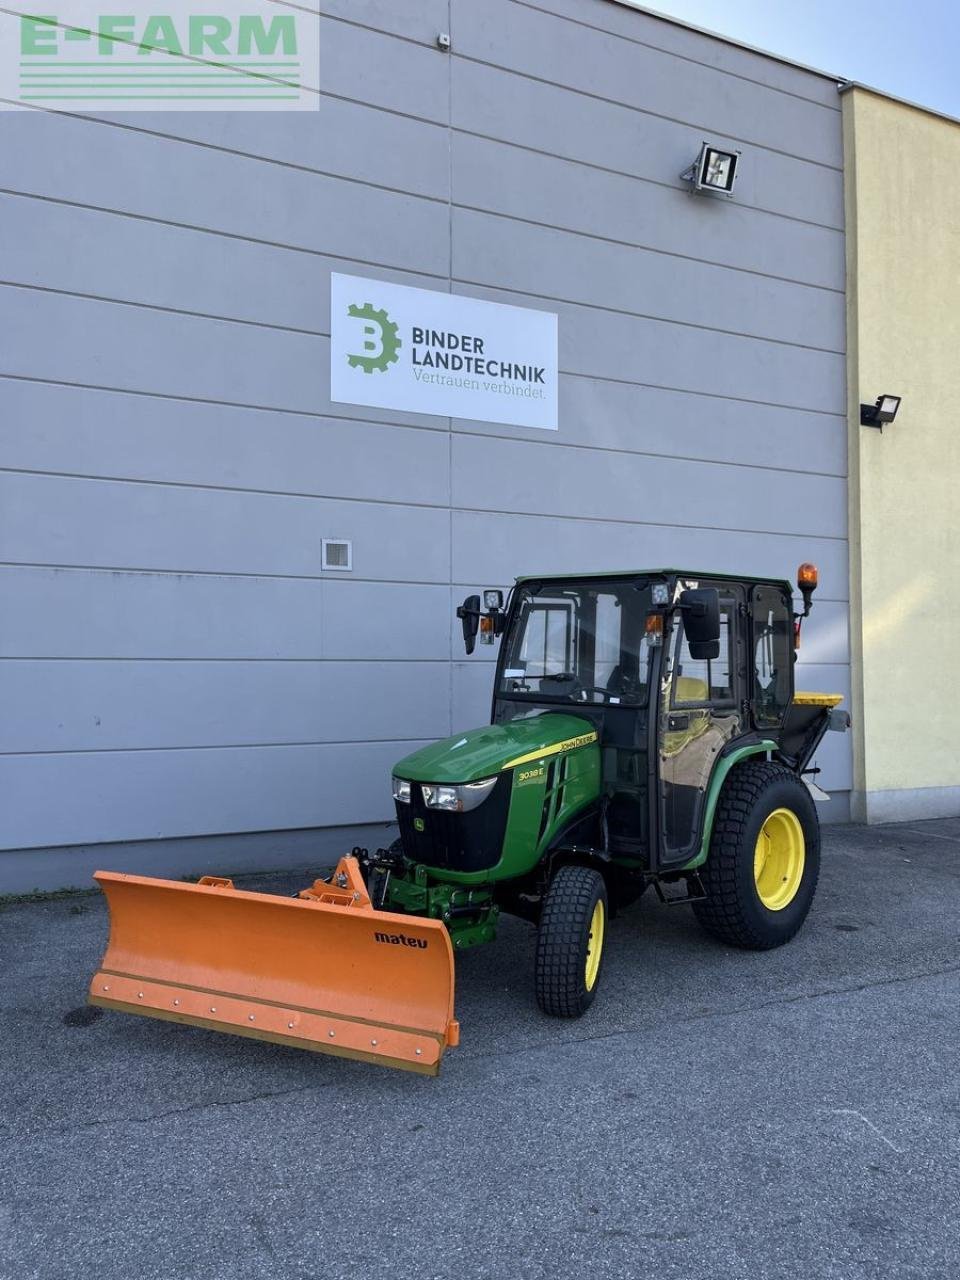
[90,564,849,1075]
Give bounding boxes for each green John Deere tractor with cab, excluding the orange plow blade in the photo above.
[371,564,849,1018]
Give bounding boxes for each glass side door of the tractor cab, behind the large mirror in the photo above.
[658,580,745,865]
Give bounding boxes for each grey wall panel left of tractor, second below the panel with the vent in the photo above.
[0,659,449,753]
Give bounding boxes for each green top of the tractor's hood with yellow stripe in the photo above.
[393,712,596,782]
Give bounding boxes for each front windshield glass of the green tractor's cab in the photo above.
[498,582,659,707]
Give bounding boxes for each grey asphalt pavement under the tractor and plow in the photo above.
[0,819,960,1280]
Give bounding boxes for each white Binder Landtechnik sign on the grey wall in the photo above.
[330,273,557,431]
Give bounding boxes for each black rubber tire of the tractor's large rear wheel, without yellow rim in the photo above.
[694,762,820,951]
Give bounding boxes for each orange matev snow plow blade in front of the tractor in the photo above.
[90,858,460,1075]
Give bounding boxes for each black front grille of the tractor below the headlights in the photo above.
[397,772,513,872]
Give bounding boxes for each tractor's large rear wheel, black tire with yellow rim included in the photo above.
[694,762,820,951]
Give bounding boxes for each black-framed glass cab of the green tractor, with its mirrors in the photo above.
[461,570,822,872]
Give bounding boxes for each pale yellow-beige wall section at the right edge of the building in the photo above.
[842,88,960,822]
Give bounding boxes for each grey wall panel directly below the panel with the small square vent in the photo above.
[0,567,451,662]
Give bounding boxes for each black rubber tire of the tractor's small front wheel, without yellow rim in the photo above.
[534,867,609,1018]
